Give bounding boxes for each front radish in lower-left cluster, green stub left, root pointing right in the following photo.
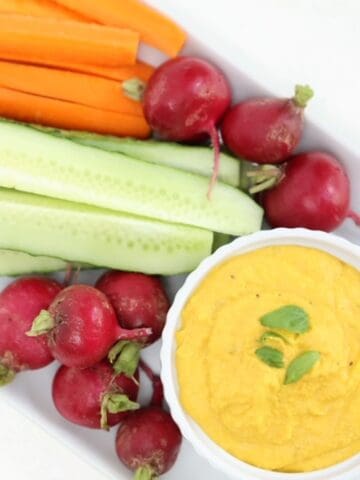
[28,285,152,370]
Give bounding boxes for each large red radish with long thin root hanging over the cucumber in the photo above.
[144,57,231,194]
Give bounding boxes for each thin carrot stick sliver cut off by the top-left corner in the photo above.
[0,0,85,21]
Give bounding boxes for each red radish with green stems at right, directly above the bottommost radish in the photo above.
[52,360,140,430]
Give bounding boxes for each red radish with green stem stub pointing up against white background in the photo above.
[221,85,313,163]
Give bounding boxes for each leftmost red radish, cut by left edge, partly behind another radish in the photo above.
[0,277,62,385]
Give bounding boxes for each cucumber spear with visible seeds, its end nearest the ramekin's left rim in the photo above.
[0,189,213,275]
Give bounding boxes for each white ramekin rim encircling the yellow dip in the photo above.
[161,229,360,480]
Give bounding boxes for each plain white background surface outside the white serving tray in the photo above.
[0,0,360,480]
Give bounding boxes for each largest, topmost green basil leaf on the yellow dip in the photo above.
[260,305,310,333]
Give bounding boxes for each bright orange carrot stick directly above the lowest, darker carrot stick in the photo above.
[0,61,143,116]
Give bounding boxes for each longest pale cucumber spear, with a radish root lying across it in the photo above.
[0,120,262,234]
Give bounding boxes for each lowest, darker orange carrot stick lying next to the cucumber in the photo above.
[0,87,150,138]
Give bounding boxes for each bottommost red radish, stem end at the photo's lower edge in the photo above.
[116,407,181,480]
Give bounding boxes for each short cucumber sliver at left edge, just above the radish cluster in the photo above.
[0,250,68,276]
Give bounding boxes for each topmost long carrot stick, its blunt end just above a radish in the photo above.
[56,0,186,57]
